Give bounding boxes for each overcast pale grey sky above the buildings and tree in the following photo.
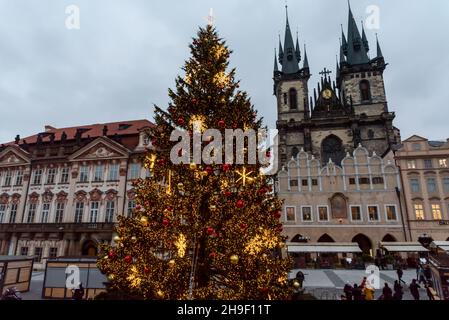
[0,0,449,142]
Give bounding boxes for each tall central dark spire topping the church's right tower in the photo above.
[346,0,370,65]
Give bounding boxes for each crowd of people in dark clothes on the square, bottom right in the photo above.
[341,265,434,301]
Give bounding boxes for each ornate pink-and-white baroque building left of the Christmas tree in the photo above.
[0,120,153,268]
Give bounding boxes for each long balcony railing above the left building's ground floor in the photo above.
[0,222,115,233]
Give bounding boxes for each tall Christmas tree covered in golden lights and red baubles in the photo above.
[98,25,293,299]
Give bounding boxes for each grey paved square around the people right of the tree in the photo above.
[290,269,428,300]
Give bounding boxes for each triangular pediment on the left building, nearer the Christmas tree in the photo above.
[69,137,129,161]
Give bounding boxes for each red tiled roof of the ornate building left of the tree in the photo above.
[6,120,154,145]
